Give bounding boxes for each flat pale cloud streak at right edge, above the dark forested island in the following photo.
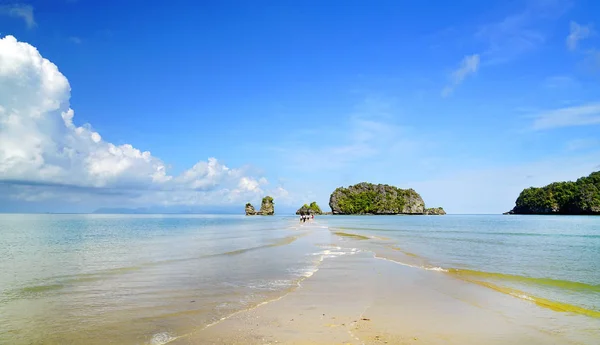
[533,103,600,130]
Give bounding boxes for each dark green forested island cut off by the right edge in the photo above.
[504,171,600,215]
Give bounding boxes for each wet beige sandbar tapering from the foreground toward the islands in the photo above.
[169,230,600,345]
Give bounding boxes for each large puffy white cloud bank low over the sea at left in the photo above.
[0,36,280,205]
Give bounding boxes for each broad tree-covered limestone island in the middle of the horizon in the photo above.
[329,182,446,215]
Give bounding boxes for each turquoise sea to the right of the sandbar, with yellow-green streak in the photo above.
[327,215,600,317]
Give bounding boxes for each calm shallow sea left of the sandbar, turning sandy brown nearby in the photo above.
[0,215,328,344]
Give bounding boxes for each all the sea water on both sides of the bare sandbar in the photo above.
[0,214,600,345]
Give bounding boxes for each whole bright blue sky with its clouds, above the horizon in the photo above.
[0,0,600,214]
